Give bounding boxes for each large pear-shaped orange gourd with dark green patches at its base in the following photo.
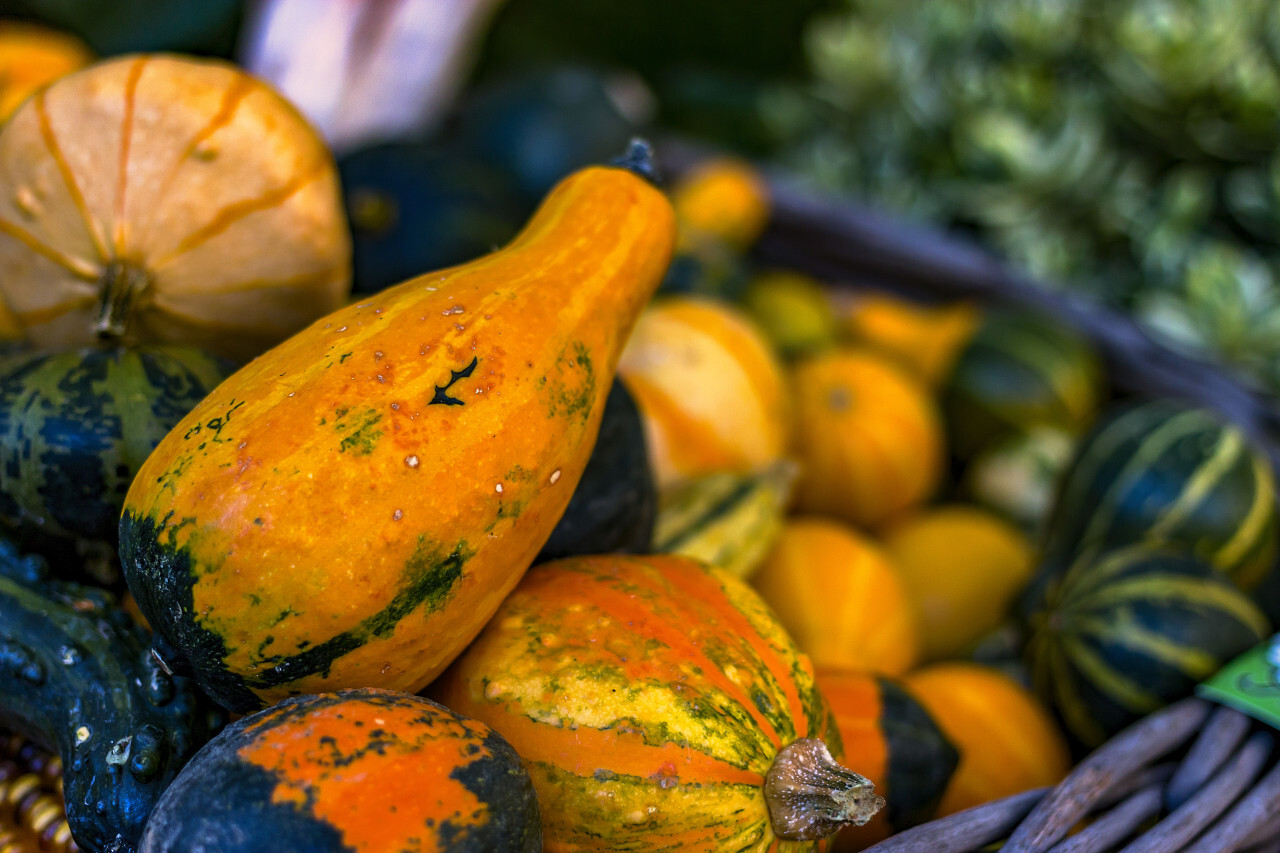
[120,159,673,710]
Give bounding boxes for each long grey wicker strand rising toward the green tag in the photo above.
[1001,697,1210,853]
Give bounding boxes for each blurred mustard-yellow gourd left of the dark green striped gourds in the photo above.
[883,505,1034,660]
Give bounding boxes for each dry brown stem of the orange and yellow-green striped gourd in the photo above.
[764,738,884,841]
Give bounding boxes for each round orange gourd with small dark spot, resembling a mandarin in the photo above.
[790,348,945,526]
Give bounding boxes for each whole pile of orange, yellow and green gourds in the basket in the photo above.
[0,23,1276,852]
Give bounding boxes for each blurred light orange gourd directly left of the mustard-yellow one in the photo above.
[751,517,920,675]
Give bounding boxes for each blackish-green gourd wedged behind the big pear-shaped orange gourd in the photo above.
[535,378,658,562]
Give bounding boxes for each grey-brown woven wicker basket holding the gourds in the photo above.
[742,162,1280,853]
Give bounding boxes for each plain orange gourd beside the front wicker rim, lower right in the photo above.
[905,662,1071,817]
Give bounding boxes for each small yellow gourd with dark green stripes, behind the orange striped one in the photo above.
[653,460,796,578]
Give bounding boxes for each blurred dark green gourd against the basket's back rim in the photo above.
[942,310,1102,460]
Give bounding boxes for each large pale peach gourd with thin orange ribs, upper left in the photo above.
[0,55,351,361]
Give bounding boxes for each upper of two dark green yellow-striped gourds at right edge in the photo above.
[1042,400,1276,589]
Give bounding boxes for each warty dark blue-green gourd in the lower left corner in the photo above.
[0,542,224,850]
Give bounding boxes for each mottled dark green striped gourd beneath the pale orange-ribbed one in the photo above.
[0,346,230,558]
